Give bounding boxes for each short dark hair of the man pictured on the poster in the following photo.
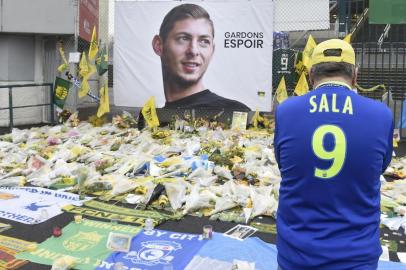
[159,4,214,42]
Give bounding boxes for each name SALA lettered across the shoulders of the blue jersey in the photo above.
[309,94,353,115]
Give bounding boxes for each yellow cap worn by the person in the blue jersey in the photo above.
[311,39,355,65]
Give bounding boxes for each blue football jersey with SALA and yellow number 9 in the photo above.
[274,83,393,270]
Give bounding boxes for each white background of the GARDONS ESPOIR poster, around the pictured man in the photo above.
[113,0,273,111]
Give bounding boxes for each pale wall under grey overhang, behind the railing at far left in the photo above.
[0,35,50,126]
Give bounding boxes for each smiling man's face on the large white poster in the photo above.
[157,18,214,85]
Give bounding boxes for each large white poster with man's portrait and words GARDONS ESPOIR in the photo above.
[113,0,273,111]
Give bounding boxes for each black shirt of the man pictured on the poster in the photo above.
[164,90,251,112]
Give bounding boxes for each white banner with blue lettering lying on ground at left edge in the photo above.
[0,187,88,224]
